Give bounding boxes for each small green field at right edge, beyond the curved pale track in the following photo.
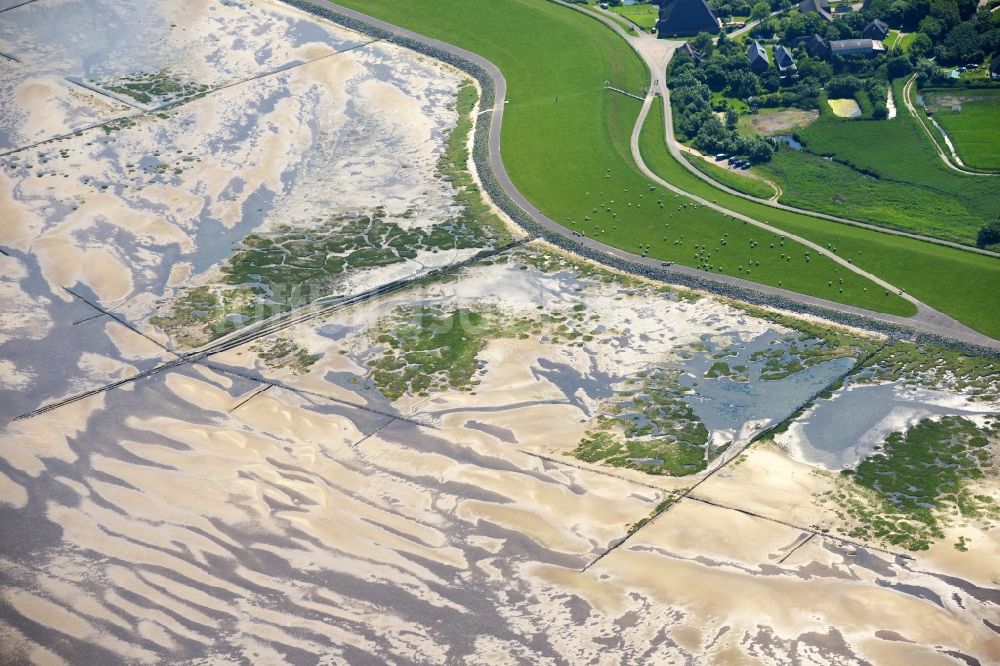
[924,89,1000,169]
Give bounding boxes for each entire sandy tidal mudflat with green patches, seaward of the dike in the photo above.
[0,0,1000,664]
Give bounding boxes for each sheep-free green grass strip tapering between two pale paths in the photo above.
[641,100,1000,339]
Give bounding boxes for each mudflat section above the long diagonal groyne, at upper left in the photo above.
[0,2,498,417]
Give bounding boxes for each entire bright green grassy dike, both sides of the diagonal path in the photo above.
[334,0,1000,336]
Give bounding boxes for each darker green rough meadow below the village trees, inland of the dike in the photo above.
[765,80,1000,245]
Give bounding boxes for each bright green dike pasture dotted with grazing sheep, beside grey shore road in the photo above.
[334,0,915,316]
